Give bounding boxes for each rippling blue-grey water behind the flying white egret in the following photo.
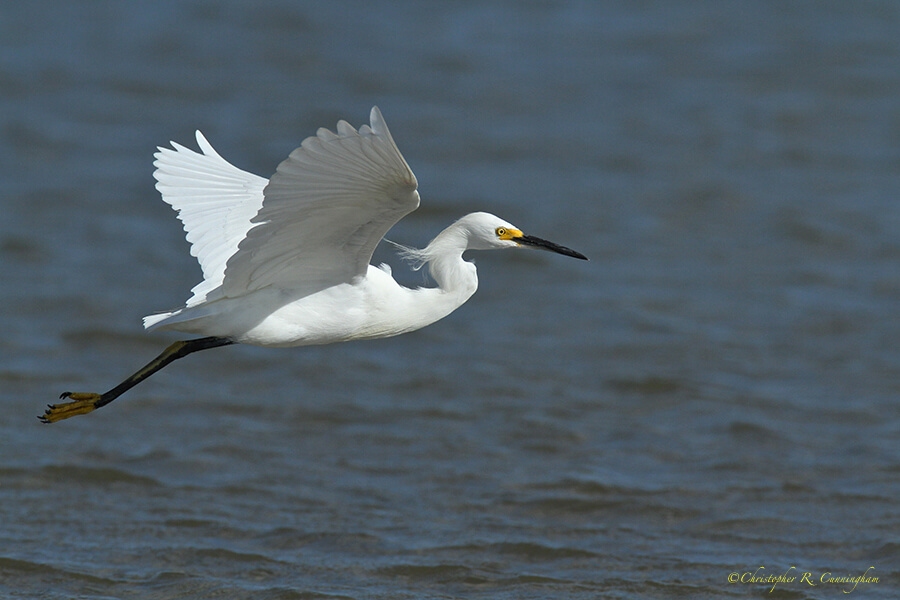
[0,1,900,599]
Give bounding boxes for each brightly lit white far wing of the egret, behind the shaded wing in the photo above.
[153,131,268,306]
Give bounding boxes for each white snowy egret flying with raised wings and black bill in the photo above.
[39,107,587,423]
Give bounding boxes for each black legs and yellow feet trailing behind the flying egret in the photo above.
[38,337,234,423]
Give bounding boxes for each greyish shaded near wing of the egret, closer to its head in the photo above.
[223,107,419,297]
